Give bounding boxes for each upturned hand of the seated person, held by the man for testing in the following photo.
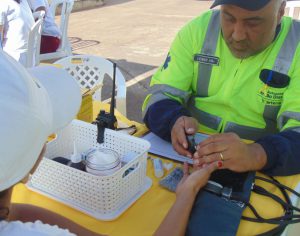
[176,162,220,197]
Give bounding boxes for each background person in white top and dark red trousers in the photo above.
[28,0,61,54]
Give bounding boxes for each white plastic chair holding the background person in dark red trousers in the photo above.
[40,0,74,61]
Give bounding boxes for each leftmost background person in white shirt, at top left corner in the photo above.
[0,0,34,65]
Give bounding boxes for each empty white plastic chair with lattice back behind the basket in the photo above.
[54,55,127,117]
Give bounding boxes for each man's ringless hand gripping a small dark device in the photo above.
[171,116,198,158]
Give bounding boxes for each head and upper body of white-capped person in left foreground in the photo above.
[0,50,102,236]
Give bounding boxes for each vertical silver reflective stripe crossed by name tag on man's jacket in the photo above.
[197,11,220,97]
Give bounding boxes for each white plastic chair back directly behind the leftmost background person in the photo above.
[25,11,45,67]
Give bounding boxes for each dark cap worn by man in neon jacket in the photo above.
[210,0,271,11]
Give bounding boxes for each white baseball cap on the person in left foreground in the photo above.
[0,50,81,191]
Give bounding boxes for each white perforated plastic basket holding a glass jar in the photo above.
[27,120,152,220]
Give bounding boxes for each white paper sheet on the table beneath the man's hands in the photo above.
[142,133,208,164]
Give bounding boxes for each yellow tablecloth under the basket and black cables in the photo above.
[12,103,300,236]
